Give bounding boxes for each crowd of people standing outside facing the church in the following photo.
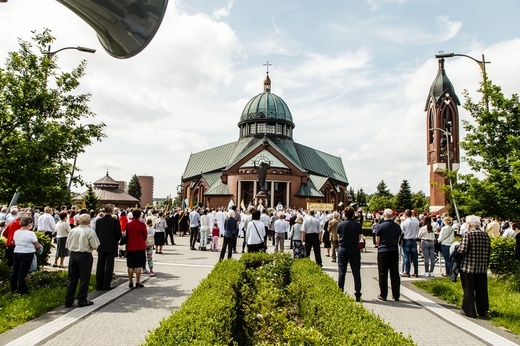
[0,204,520,317]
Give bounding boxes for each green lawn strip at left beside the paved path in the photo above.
[0,270,96,333]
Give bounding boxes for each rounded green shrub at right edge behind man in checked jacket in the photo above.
[489,237,520,279]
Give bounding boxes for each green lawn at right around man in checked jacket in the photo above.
[413,276,520,335]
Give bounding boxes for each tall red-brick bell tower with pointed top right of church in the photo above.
[424,59,460,212]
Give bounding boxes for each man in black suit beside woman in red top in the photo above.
[96,204,121,291]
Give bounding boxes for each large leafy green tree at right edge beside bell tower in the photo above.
[454,81,520,220]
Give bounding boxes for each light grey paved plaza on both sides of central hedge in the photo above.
[0,237,520,346]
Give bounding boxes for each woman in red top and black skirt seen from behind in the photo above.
[126,209,148,288]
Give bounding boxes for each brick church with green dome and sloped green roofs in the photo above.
[181,71,348,209]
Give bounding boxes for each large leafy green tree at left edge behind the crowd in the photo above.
[0,29,105,205]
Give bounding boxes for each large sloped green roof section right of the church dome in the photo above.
[295,143,348,184]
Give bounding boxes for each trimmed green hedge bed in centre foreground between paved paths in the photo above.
[146,253,414,345]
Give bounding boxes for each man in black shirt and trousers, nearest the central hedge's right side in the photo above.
[338,206,363,302]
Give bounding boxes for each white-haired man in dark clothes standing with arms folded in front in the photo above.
[376,209,401,301]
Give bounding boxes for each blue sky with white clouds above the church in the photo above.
[0,0,520,197]
